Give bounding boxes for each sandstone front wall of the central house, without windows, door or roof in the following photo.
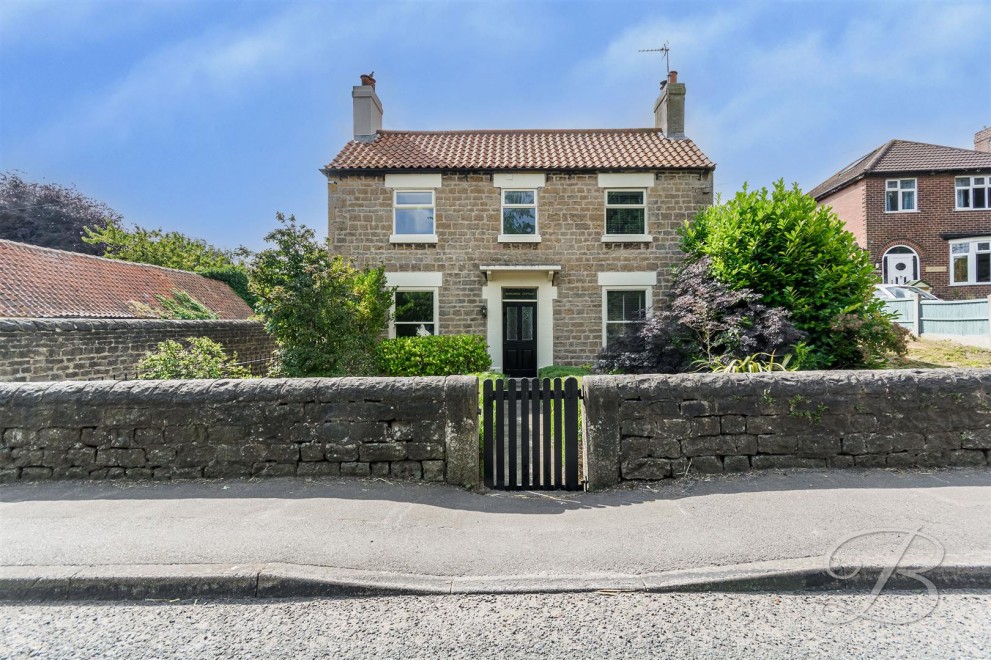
[328,171,712,365]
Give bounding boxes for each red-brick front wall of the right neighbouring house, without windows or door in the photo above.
[863,173,991,300]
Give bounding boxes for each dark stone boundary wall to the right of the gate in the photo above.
[583,369,991,488]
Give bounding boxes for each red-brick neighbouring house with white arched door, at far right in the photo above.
[809,134,991,299]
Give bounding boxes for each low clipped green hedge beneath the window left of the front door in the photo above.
[377,335,492,376]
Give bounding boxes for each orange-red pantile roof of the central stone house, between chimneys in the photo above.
[325,128,715,172]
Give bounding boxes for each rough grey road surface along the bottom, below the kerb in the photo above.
[0,592,991,659]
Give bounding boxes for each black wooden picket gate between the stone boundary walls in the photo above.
[482,378,582,490]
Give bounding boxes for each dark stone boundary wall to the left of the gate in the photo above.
[0,376,478,486]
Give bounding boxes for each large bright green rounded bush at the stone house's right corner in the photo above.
[682,180,904,368]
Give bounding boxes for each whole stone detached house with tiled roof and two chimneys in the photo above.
[322,72,715,376]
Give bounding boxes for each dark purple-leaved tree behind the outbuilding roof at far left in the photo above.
[0,172,123,255]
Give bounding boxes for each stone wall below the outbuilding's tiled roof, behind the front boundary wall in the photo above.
[0,318,275,381]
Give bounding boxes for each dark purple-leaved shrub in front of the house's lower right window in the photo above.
[597,257,802,373]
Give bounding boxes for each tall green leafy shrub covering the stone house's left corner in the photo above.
[250,213,392,376]
